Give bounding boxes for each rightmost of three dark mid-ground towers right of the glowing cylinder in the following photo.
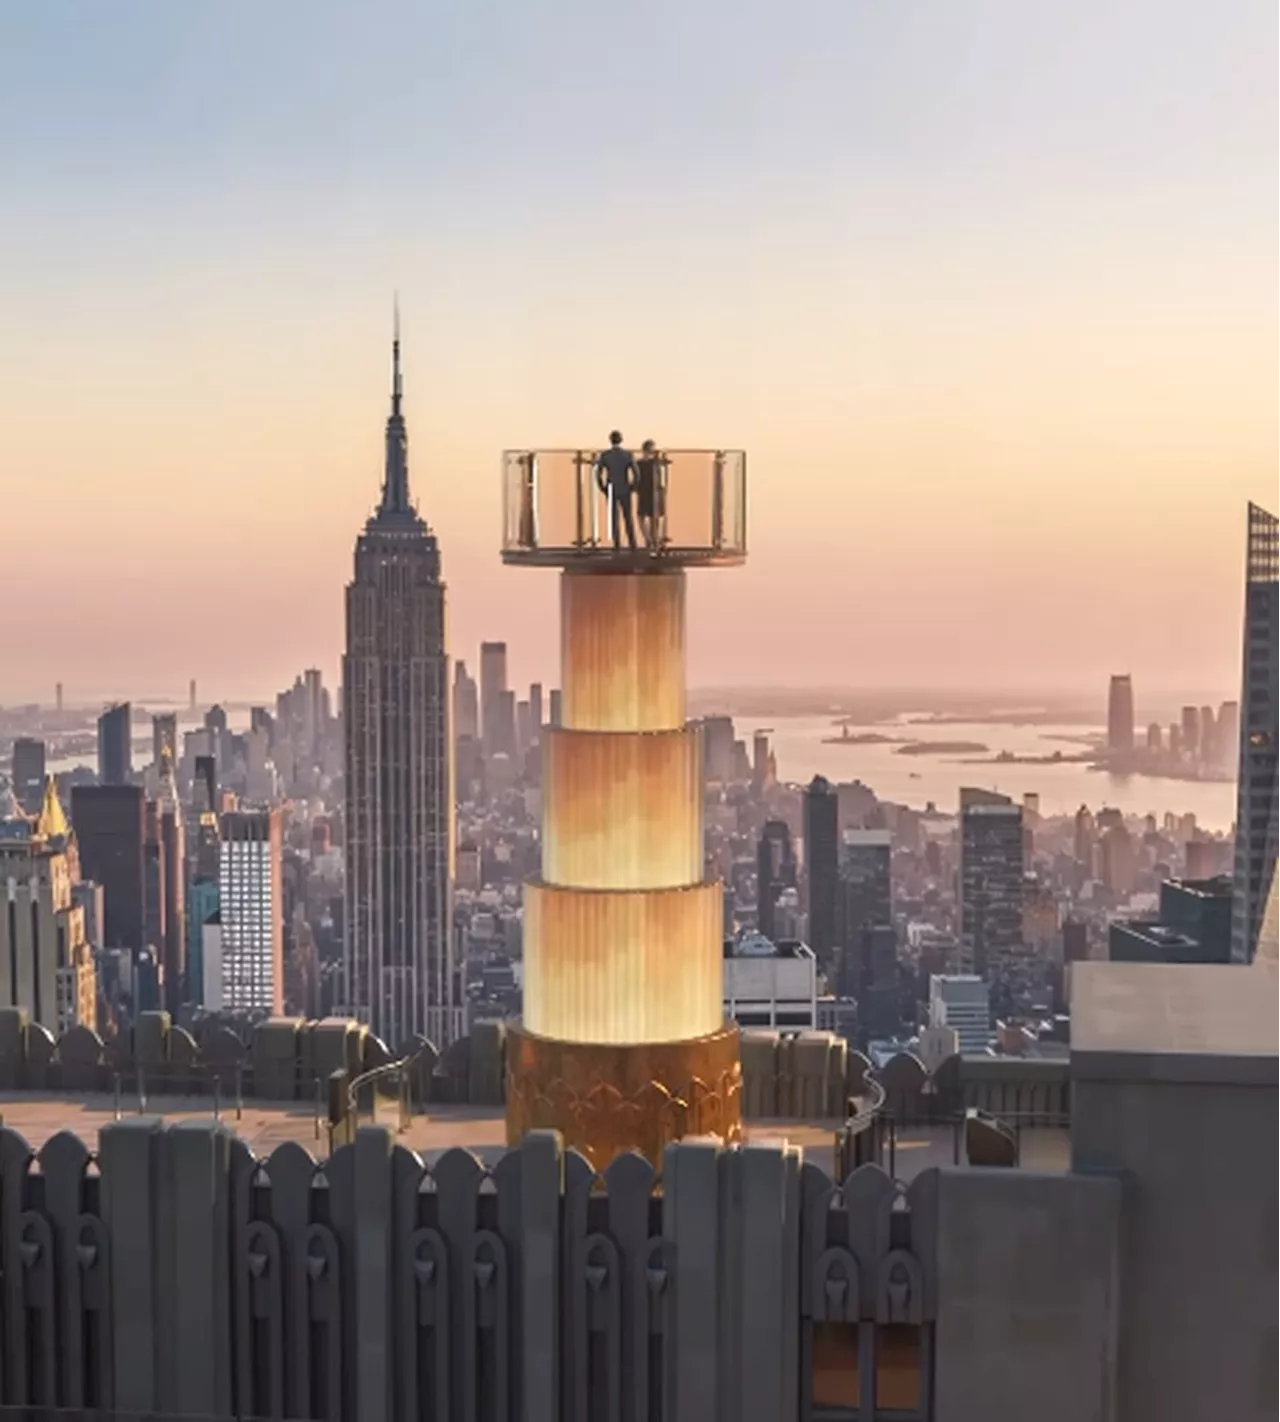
[960,789,1024,980]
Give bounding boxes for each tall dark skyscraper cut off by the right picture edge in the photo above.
[1232,503,1280,963]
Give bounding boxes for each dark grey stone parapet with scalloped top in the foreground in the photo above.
[0,1116,1118,1422]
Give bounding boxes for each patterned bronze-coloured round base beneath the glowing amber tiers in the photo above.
[506,1022,742,1170]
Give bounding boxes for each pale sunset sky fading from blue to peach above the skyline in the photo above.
[0,0,1280,702]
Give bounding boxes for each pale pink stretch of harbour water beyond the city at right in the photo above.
[735,712,1236,832]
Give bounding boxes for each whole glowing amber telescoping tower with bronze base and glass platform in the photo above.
[503,451,745,1169]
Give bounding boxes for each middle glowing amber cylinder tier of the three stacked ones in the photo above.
[542,725,703,889]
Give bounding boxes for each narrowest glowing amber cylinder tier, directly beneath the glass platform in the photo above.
[560,572,686,731]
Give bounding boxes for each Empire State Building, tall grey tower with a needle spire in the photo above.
[343,320,462,1049]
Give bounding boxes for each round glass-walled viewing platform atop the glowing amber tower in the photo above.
[502,449,747,573]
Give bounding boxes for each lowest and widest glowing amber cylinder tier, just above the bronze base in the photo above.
[523,882,724,1044]
